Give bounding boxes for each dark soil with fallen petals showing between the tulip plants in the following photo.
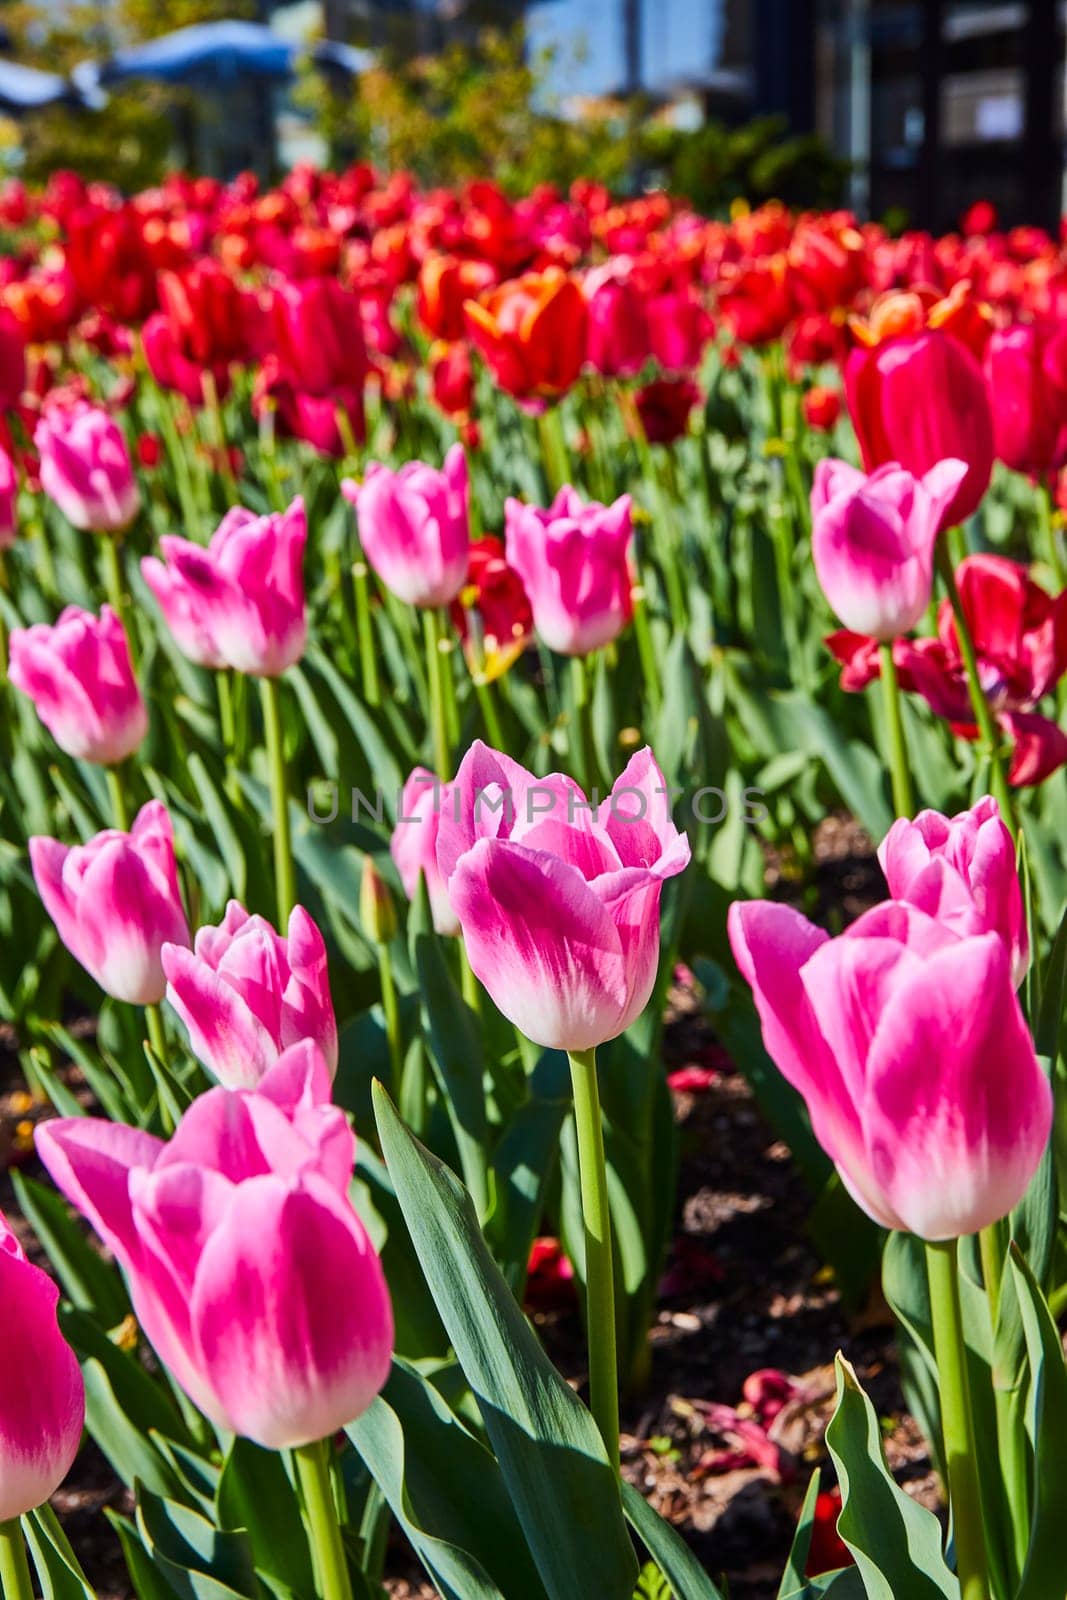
[0,819,937,1600]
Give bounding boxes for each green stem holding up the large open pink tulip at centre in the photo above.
[569,1050,619,1470]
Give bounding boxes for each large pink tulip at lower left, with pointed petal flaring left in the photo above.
[37,1042,392,1450]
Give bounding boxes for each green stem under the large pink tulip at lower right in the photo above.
[926,1240,989,1600]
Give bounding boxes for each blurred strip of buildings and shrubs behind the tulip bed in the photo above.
[0,0,1067,229]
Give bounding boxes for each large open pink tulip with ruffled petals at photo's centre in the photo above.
[437,741,689,1051]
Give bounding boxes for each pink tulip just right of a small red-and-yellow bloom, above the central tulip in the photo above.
[504,485,633,656]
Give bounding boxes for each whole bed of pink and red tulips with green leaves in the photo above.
[0,168,1067,1600]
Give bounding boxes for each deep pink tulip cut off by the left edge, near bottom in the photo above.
[0,1213,85,1523]
